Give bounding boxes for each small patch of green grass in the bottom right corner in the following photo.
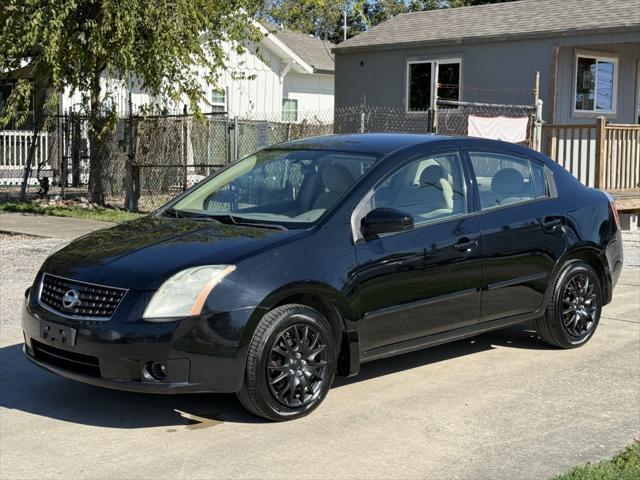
[553,440,640,480]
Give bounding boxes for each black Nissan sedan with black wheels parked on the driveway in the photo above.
[22,134,622,420]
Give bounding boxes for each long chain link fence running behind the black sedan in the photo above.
[0,102,536,212]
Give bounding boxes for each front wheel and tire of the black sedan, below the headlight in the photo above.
[237,304,337,421]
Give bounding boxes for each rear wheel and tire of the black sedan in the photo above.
[536,260,602,348]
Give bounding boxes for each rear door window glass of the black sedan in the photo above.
[469,152,549,210]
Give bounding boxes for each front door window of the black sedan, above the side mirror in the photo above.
[371,152,467,225]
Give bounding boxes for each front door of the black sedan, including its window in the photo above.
[355,150,481,357]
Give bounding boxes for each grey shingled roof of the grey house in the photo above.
[334,0,640,51]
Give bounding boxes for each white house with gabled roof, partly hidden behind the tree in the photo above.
[60,22,334,122]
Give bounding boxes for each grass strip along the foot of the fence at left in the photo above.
[0,202,142,223]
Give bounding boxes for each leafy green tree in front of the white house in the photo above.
[0,0,262,204]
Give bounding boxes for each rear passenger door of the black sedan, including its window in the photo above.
[467,149,565,322]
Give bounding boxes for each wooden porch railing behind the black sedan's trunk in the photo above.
[542,117,640,190]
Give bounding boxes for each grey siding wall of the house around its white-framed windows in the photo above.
[335,29,640,123]
